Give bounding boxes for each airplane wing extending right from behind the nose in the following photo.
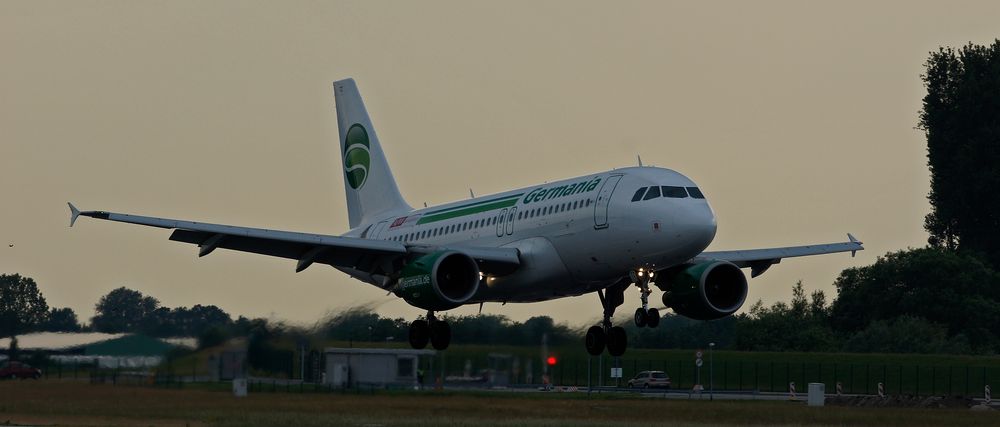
[692,233,865,277]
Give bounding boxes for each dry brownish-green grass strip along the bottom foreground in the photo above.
[0,380,1000,427]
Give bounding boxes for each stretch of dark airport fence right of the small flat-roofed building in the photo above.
[428,356,1000,396]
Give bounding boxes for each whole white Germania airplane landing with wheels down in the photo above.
[69,79,864,356]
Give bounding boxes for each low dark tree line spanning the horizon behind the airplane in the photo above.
[0,247,1000,354]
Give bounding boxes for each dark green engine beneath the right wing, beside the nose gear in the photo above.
[657,261,747,320]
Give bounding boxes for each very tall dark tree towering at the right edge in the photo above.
[919,40,1000,266]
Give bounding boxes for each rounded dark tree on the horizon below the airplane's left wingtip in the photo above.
[90,287,160,333]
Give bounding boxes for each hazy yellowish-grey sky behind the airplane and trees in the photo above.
[0,1,1000,325]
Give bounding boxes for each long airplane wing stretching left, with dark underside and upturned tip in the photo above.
[69,203,520,276]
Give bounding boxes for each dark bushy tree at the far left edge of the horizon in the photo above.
[0,274,49,337]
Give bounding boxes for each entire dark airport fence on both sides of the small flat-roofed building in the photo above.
[35,352,1000,397]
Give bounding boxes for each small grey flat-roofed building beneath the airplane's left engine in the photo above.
[323,348,434,387]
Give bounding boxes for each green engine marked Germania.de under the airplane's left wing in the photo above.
[395,251,479,310]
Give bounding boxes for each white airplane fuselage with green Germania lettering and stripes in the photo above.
[345,167,716,303]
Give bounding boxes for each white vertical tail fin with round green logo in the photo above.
[333,79,413,228]
